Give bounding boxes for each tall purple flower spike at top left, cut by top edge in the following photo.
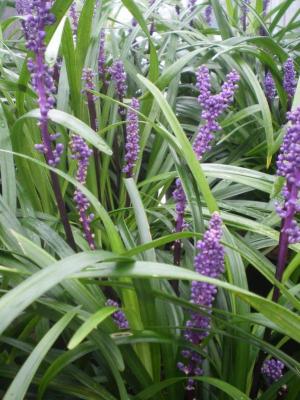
[16,0,63,166]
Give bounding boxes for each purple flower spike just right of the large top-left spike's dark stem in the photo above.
[71,135,95,250]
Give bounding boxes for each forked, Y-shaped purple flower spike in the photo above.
[193,65,240,161]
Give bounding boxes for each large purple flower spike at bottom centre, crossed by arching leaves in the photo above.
[177,213,225,390]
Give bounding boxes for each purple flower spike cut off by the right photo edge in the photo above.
[277,107,300,243]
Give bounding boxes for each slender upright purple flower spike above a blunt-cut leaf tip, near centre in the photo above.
[123,98,140,178]
